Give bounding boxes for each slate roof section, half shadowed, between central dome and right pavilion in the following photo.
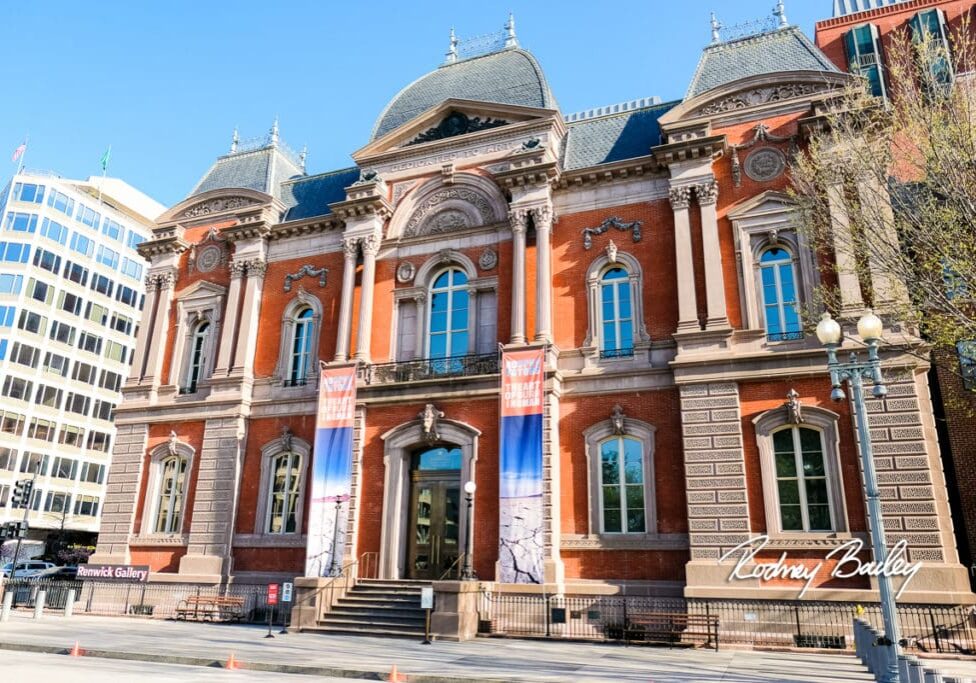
[562,101,679,171]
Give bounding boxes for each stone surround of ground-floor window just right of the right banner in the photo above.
[583,416,658,547]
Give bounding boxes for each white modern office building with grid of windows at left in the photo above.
[0,171,164,543]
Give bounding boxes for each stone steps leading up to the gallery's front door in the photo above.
[314,579,430,638]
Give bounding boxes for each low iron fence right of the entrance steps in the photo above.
[478,592,976,655]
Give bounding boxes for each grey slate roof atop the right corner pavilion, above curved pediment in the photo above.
[685,26,839,99]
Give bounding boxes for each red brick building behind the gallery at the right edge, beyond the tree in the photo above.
[816,0,976,587]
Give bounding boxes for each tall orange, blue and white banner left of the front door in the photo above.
[305,365,356,576]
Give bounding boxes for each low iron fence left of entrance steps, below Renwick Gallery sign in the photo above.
[4,579,290,625]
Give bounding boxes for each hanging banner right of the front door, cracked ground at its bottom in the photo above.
[498,348,545,583]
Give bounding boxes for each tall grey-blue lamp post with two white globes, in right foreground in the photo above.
[817,309,900,683]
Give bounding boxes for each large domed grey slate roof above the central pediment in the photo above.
[370,48,557,141]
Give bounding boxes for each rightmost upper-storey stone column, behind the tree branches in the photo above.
[857,175,908,312]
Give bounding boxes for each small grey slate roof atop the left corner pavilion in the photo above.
[188,143,305,199]
